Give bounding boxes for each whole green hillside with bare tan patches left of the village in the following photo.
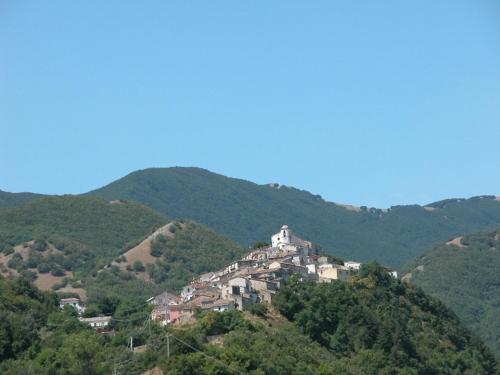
[0,196,246,310]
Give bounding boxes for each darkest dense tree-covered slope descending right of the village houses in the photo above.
[275,264,495,374]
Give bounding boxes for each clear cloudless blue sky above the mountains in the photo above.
[0,0,500,207]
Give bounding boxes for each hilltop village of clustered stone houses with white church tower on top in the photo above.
[149,225,390,324]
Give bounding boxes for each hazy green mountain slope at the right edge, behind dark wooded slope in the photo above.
[404,230,500,358]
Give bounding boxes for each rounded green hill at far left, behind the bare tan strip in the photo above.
[0,196,167,280]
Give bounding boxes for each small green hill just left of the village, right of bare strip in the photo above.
[86,222,246,303]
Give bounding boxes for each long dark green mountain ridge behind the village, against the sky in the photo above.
[88,167,500,267]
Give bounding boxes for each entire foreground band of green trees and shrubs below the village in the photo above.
[0,264,498,375]
